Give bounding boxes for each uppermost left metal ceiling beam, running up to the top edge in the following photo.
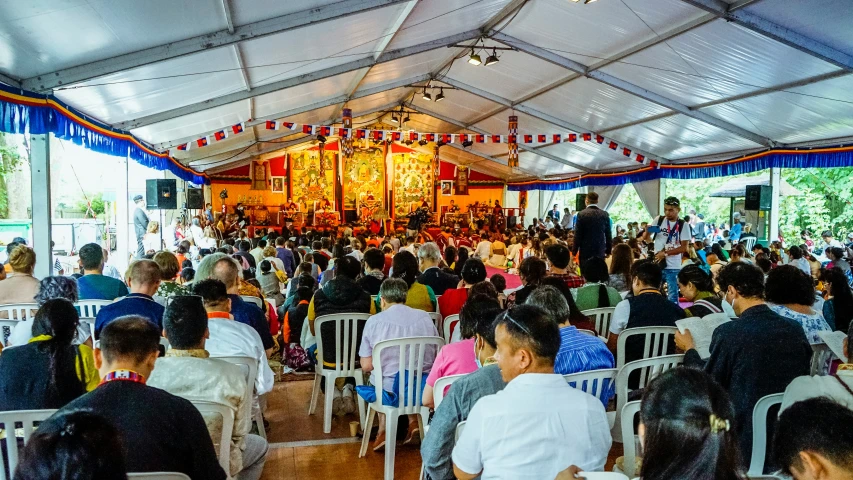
[22,0,408,91]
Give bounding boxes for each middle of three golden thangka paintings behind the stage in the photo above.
[343,147,385,223]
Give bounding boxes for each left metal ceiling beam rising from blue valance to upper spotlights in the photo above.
[115,30,480,130]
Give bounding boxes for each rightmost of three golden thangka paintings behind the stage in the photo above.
[393,152,435,219]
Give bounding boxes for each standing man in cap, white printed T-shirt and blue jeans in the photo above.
[643,197,692,305]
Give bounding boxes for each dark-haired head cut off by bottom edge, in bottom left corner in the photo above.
[15,410,127,480]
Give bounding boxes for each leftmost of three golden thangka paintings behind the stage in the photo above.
[288,150,338,212]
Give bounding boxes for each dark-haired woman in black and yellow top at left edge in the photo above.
[0,300,100,411]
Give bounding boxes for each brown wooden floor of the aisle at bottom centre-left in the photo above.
[261,376,622,480]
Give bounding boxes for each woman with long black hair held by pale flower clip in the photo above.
[639,368,745,480]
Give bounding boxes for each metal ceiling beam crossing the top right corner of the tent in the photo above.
[681,0,853,70]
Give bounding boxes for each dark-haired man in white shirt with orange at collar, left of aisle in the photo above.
[193,279,275,396]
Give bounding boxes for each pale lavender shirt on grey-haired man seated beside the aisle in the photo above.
[358,304,440,392]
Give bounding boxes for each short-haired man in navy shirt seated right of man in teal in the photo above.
[95,260,165,339]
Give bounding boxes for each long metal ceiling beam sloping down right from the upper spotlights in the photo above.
[492,33,776,147]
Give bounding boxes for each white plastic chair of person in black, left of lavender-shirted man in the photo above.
[308,313,370,433]
